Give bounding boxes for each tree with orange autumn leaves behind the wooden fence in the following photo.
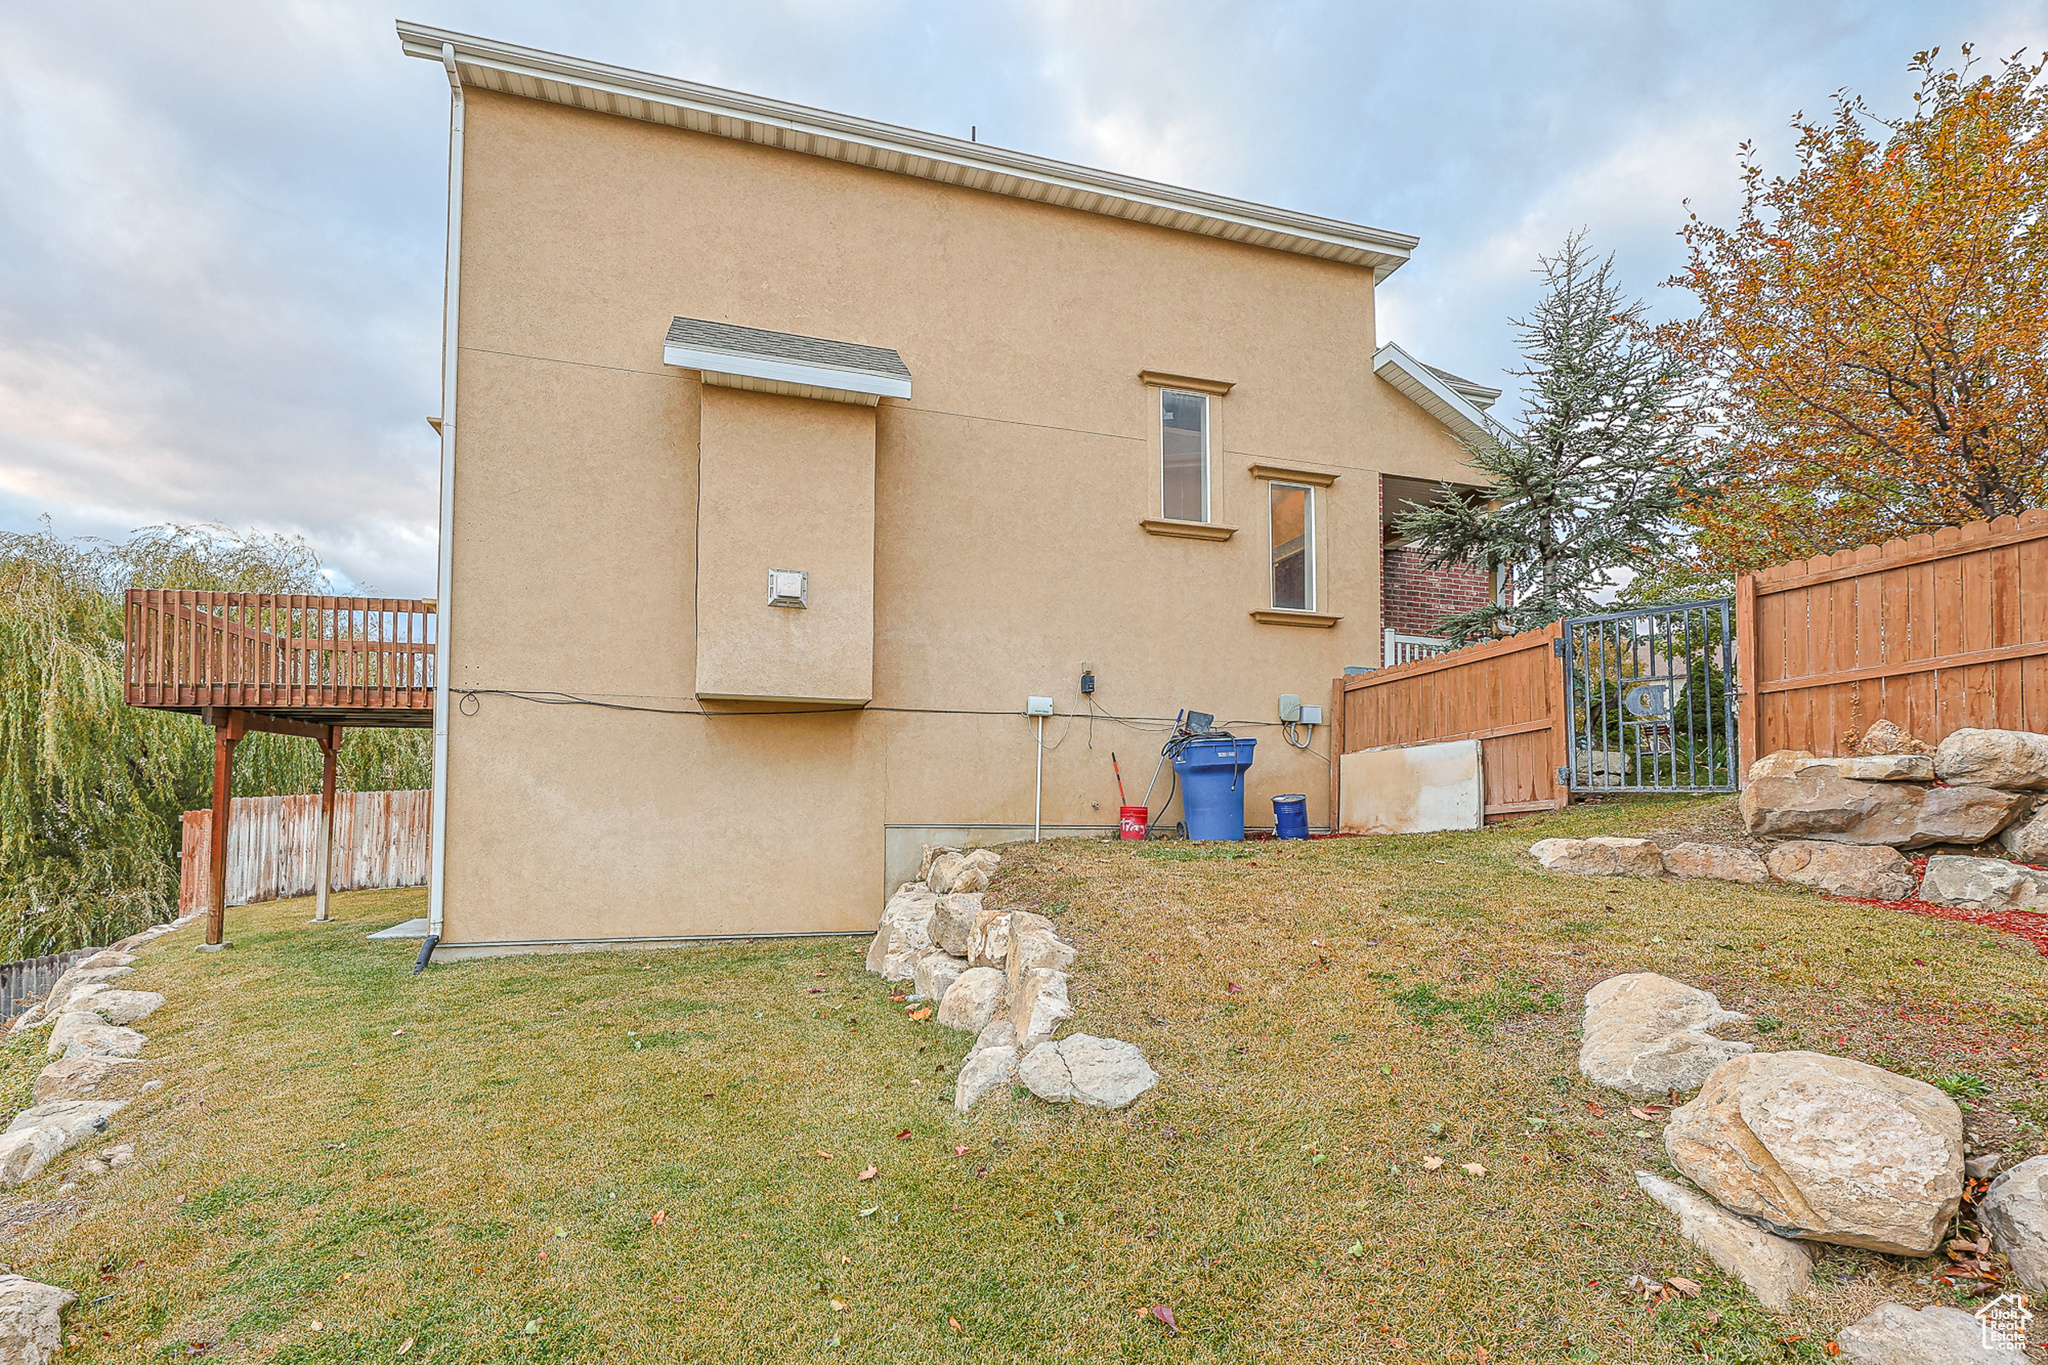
[1661,47,2048,577]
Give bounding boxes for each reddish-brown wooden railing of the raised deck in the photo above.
[125,589,436,722]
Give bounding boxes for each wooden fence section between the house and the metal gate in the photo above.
[1329,622,1569,825]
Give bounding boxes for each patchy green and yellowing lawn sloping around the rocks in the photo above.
[16,800,2048,1365]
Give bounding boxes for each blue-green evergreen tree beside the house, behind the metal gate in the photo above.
[1399,233,1704,639]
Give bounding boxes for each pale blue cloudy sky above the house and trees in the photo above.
[0,0,2048,596]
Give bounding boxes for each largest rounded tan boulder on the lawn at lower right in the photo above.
[1665,1052,1962,1257]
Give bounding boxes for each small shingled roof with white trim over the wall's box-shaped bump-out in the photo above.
[662,317,909,407]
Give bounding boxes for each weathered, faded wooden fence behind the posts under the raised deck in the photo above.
[178,792,434,915]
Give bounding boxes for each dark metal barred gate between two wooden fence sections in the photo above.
[1556,598,1739,792]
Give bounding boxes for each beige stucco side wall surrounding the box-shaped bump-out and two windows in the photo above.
[444,90,1462,943]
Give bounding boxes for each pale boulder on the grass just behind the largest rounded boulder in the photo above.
[1579,972,1751,1099]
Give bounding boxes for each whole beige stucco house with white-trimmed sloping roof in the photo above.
[399,23,1497,958]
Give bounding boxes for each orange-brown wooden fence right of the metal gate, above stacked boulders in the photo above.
[1735,510,2048,769]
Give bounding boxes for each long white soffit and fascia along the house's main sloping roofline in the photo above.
[397,20,1419,278]
